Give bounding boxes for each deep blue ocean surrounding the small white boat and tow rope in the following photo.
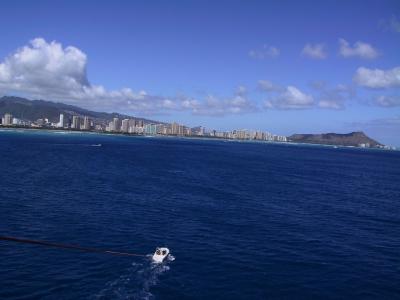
[0,131,400,299]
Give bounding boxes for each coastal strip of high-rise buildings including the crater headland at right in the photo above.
[0,103,388,150]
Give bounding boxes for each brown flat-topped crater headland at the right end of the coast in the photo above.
[288,131,382,147]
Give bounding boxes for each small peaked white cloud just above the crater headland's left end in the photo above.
[264,86,314,109]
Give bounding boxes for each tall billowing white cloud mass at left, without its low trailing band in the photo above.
[0,38,89,93]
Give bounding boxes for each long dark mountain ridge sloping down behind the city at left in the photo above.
[0,96,163,124]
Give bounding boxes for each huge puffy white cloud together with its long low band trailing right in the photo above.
[0,38,254,115]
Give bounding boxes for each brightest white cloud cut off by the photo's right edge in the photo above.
[353,67,400,89]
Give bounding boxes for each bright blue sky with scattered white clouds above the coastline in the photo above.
[0,1,400,146]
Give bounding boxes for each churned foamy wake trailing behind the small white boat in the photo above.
[93,255,175,299]
